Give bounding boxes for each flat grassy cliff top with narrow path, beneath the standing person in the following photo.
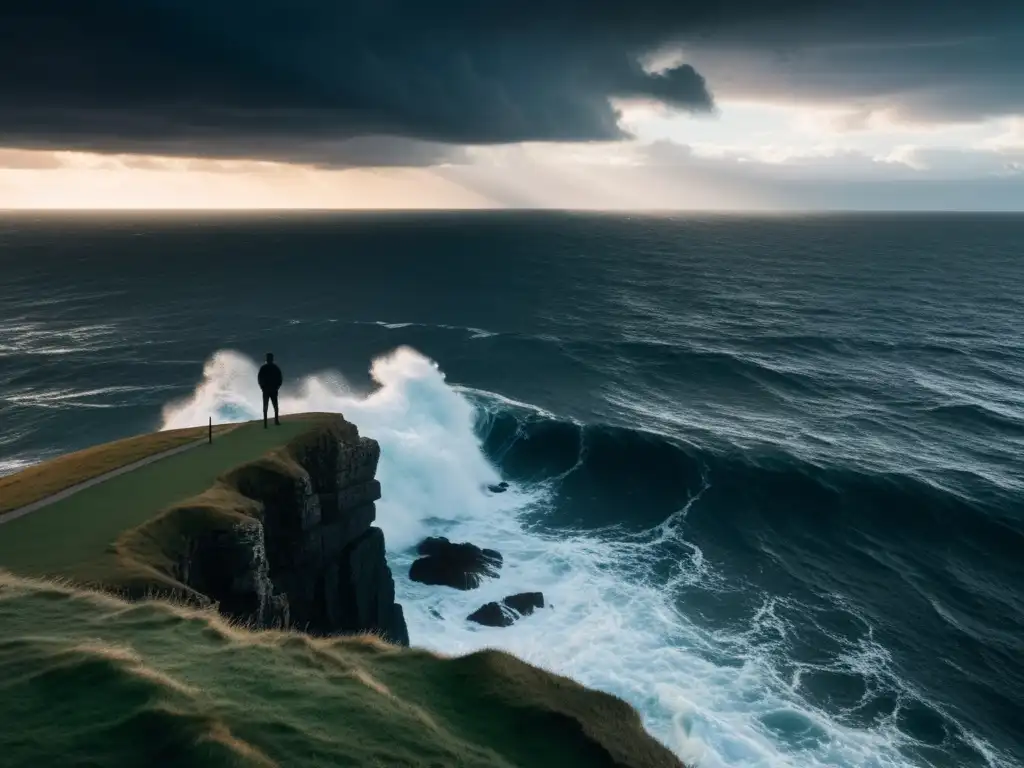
[0,414,354,587]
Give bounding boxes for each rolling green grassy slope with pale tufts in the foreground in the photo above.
[0,571,679,768]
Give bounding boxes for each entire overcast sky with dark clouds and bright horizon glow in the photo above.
[0,0,1024,211]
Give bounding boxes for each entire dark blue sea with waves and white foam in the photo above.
[0,213,1024,768]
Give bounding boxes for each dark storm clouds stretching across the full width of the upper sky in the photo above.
[0,0,1024,166]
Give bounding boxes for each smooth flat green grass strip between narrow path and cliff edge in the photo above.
[0,419,312,581]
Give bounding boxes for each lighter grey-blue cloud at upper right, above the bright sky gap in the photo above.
[675,27,1024,123]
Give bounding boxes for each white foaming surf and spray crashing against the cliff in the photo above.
[163,347,946,768]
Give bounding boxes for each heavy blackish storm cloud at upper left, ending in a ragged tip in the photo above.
[0,0,712,165]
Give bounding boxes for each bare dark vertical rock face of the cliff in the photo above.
[178,419,409,645]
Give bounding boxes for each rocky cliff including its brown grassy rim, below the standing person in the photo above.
[116,415,409,645]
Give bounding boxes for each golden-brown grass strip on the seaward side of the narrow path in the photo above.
[0,424,234,514]
